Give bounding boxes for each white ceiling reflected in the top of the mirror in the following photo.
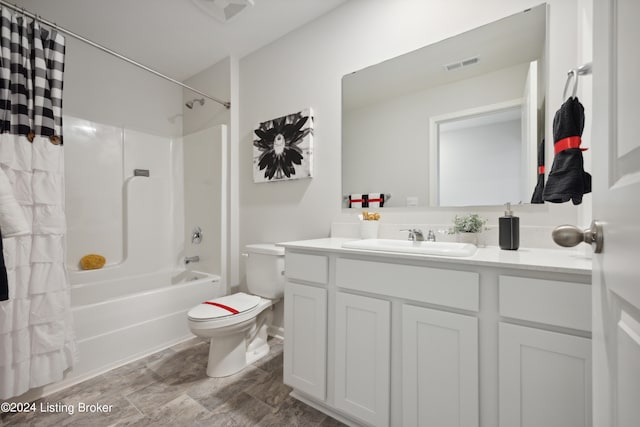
[342,5,546,110]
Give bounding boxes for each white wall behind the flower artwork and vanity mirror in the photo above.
[239,0,578,284]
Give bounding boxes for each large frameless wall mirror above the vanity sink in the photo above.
[342,4,546,207]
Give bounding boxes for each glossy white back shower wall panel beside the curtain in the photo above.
[65,117,176,280]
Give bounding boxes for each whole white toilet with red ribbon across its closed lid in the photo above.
[188,243,284,378]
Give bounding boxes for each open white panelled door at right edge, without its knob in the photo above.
[591,0,640,427]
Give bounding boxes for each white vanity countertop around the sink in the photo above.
[278,237,591,276]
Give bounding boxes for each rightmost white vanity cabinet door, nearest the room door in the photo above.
[498,323,591,427]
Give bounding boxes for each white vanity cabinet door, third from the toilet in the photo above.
[402,305,479,427]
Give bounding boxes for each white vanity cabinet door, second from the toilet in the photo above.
[335,292,391,426]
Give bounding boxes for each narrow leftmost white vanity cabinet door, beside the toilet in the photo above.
[284,282,327,400]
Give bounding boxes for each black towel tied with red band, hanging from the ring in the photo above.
[543,97,591,205]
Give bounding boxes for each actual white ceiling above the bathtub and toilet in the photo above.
[9,0,346,81]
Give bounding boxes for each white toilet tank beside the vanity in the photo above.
[246,243,284,299]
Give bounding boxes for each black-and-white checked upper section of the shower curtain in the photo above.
[0,8,65,144]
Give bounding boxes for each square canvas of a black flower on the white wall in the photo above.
[253,108,313,183]
